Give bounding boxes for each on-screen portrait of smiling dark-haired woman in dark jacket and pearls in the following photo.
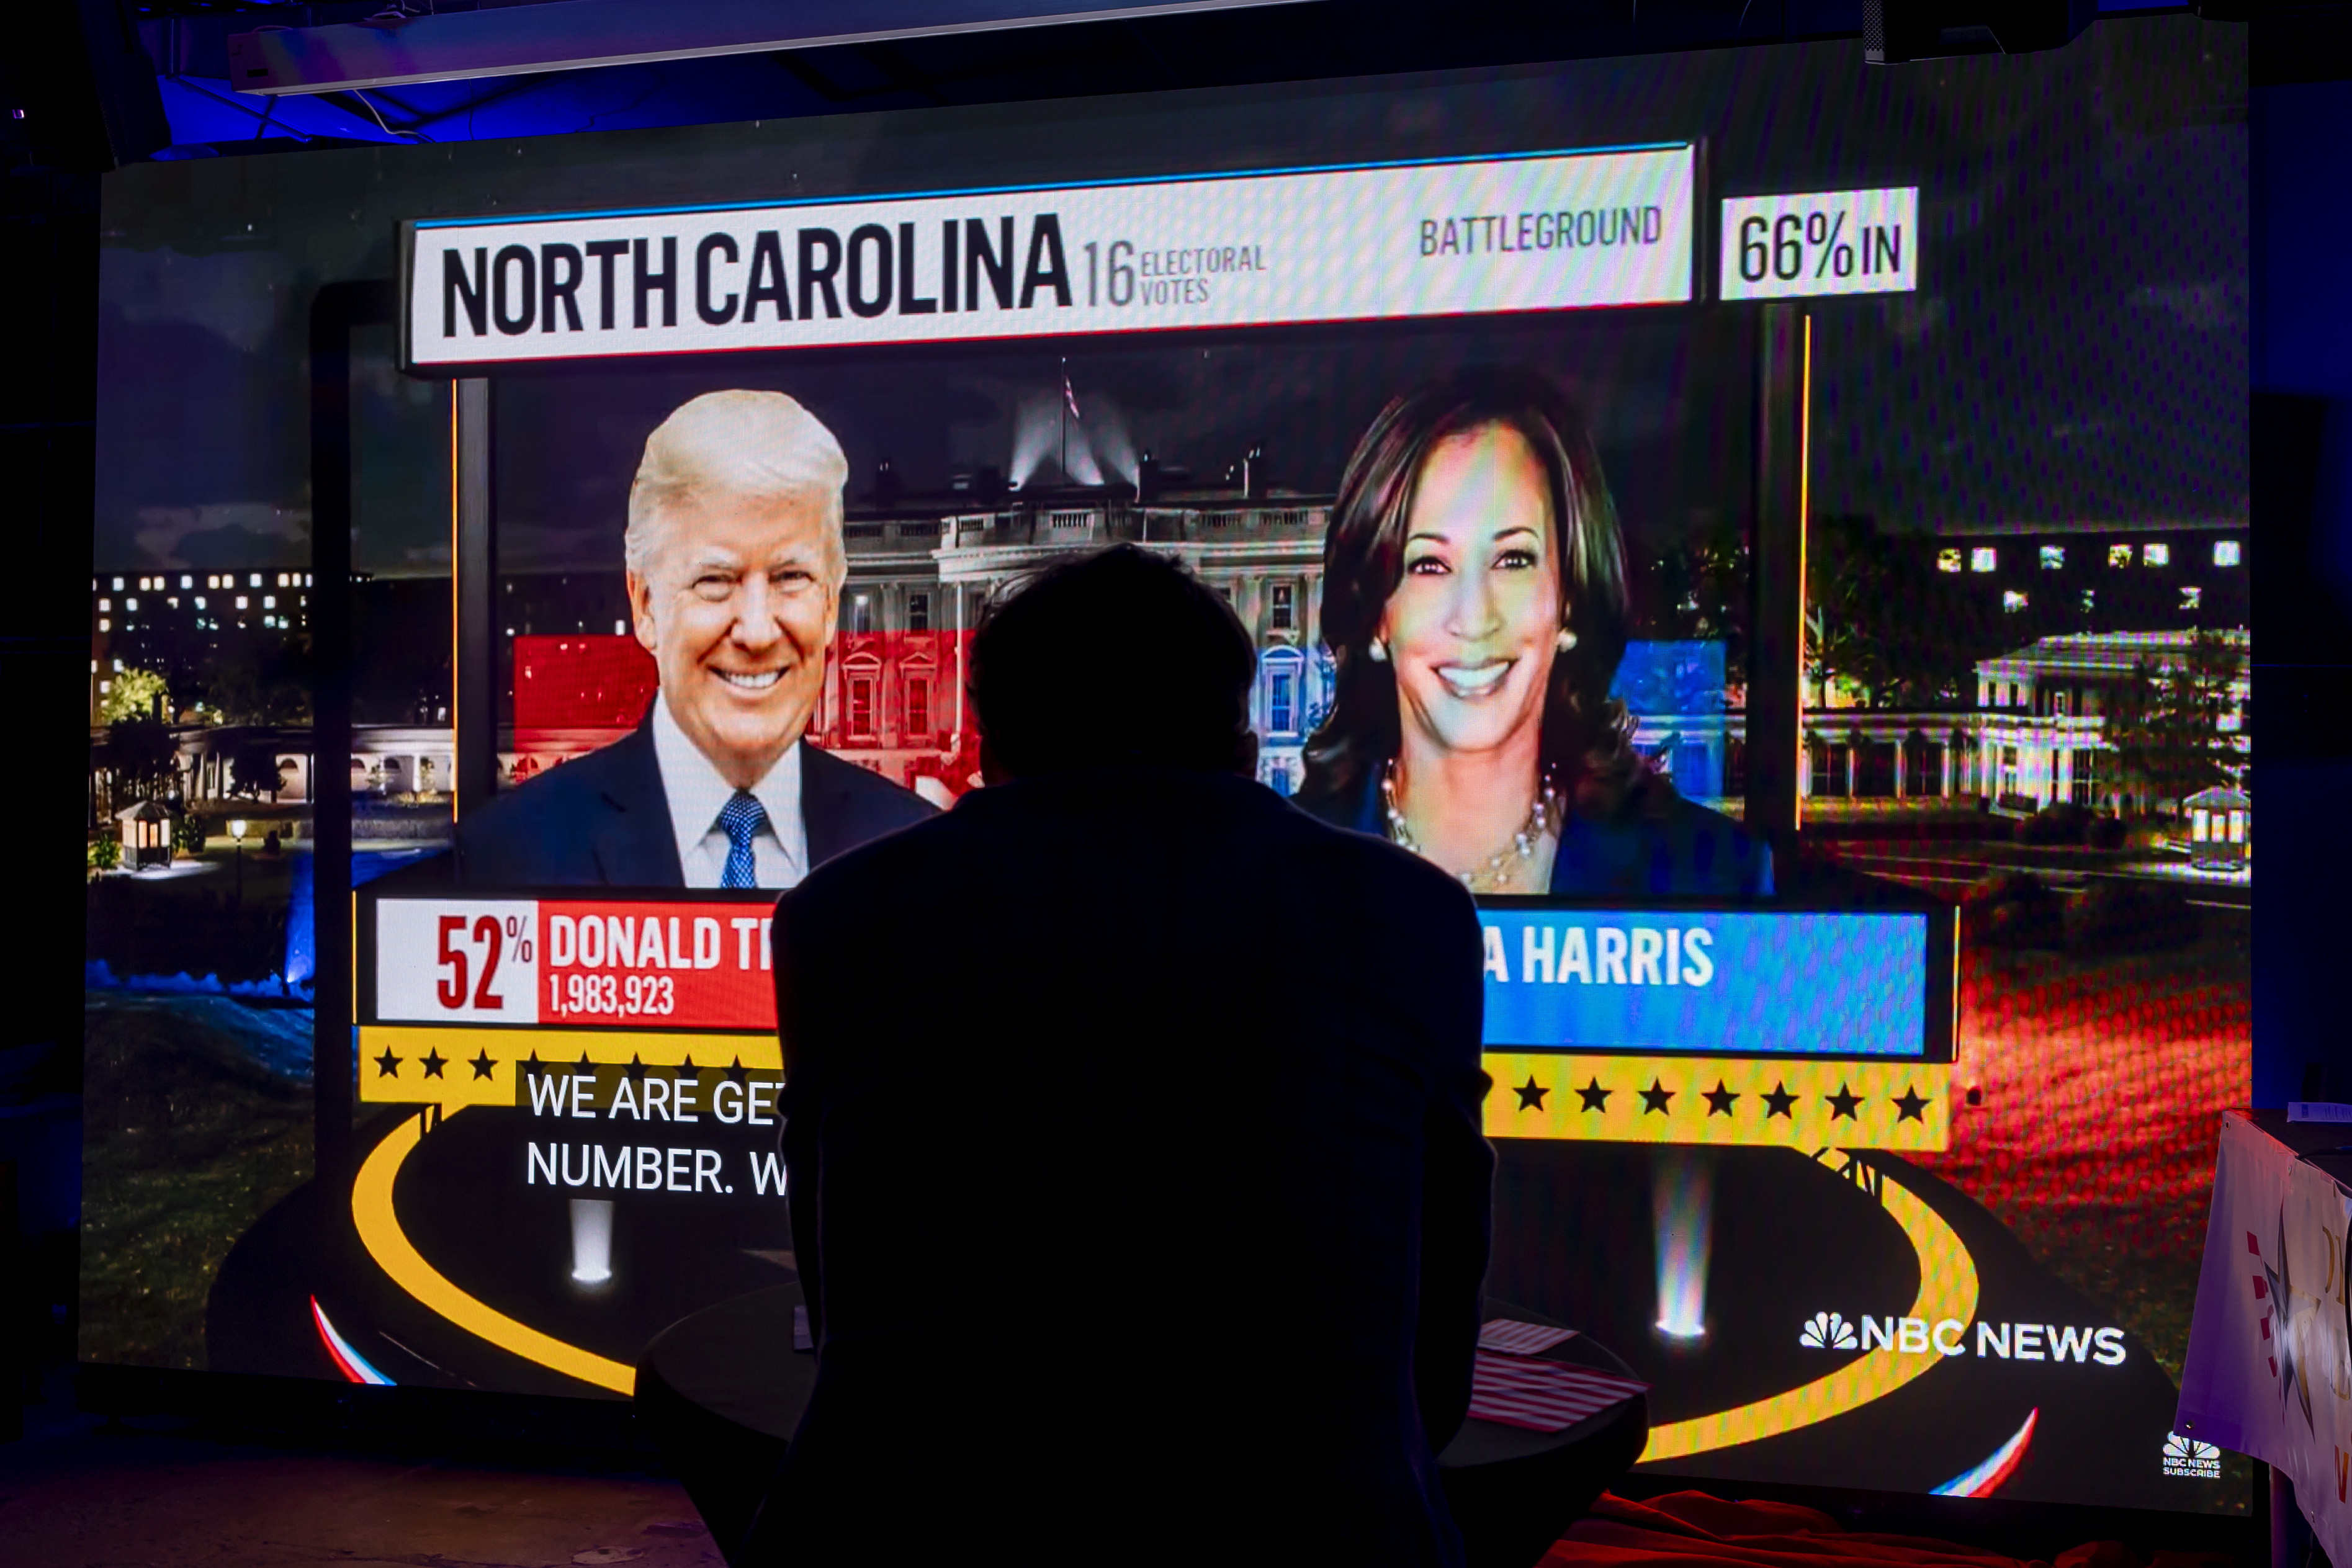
[1298,369,1771,898]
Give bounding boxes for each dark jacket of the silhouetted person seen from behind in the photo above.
[738,769,1494,1568]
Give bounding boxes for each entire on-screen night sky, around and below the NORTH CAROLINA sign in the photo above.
[96,14,2248,573]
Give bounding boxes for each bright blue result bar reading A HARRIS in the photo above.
[1479,910,1929,1058]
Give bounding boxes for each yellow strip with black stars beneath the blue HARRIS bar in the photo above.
[1486,1051,1952,1152]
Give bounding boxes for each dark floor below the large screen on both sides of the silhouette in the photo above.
[0,1368,2276,1568]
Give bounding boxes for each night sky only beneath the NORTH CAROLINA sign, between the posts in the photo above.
[482,310,1753,569]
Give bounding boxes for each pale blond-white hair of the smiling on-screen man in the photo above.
[621,390,849,588]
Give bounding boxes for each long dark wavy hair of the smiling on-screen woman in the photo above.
[1298,369,1649,813]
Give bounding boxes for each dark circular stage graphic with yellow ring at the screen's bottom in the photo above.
[209,1107,2220,1507]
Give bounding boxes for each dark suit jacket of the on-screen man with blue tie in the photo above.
[456,719,938,889]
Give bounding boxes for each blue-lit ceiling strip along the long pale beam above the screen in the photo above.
[52,0,1910,153]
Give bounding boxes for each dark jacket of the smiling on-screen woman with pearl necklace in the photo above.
[1298,776,1774,898]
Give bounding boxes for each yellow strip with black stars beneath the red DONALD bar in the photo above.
[360,1025,783,1112]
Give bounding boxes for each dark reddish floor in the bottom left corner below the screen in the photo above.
[0,1371,720,1568]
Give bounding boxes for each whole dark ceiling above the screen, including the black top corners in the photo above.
[0,0,2352,172]
